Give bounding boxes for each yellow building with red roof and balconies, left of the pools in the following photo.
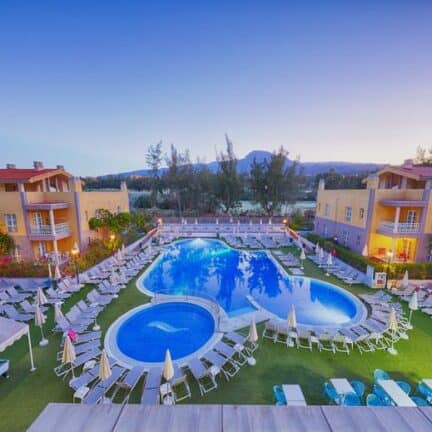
[0,162,129,261]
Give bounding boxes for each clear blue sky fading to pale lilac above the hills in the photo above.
[0,0,432,175]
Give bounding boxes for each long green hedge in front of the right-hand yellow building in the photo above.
[306,233,432,279]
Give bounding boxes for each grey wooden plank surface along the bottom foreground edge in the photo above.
[29,403,432,432]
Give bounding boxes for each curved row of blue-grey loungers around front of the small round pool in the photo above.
[62,332,253,405]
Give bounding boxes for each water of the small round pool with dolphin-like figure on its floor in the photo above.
[116,302,215,362]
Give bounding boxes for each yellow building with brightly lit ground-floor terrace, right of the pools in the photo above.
[315,160,432,262]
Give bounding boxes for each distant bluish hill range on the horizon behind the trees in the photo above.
[102,150,384,177]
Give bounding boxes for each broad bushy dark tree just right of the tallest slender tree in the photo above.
[250,147,301,215]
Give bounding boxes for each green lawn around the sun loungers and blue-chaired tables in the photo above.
[0,251,432,431]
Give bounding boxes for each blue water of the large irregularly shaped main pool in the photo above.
[141,239,364,326]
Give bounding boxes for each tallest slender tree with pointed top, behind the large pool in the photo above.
[215,134,242,213]
